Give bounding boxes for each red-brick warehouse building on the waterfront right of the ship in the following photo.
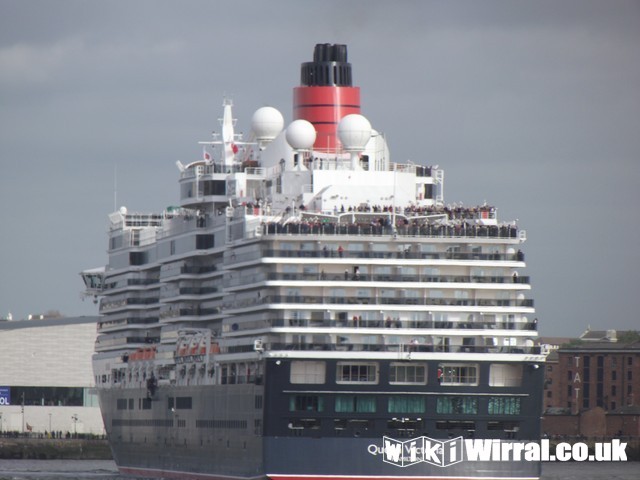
[543,330,640,437]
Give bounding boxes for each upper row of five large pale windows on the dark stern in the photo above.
[289,361,522,387]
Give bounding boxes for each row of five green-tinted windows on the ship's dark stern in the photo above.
[289,394,522,415]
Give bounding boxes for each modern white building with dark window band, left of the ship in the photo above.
[0,316,104,435]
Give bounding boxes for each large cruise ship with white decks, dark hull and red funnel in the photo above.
[82,44,544,480]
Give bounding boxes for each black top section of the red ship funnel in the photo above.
[300,43,352,87]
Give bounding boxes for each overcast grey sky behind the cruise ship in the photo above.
[0,0,640,336]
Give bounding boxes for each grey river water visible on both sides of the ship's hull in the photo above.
[0,460,640,480]
